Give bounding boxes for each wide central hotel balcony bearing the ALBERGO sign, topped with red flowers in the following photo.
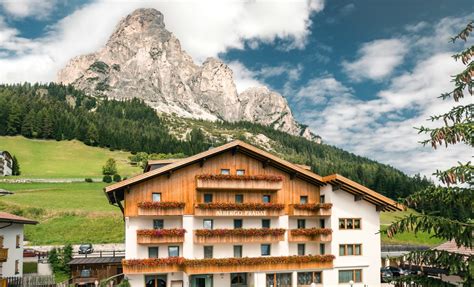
[194,203,285,217]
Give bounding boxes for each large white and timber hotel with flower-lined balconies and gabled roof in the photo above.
[105,141,403,287]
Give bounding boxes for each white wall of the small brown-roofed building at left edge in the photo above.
[0,223,23,277]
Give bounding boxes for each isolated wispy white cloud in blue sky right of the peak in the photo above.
[342,39,408,81]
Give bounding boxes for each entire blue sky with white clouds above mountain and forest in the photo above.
[0,0,474,178]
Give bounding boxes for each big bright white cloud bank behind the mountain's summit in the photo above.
[0,0,324,83]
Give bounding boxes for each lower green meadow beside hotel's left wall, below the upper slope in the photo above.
[0,183,124,245]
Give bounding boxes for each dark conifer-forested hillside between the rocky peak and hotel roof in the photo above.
[0,84,430,199]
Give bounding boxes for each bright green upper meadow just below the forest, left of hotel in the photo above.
[0,136,140,178]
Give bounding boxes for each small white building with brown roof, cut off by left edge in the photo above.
[0,211,38,278]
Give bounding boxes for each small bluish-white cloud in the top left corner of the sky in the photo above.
[0,0,57,19]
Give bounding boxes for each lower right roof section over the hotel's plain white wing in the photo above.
[323,174,405,211]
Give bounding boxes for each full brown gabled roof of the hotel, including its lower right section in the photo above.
[104,140,403,211]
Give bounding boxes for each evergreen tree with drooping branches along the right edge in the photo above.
[387,21,474,286]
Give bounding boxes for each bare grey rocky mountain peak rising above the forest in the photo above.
[58,9,319,141]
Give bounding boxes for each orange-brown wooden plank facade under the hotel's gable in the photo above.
[124,150,319,216]
